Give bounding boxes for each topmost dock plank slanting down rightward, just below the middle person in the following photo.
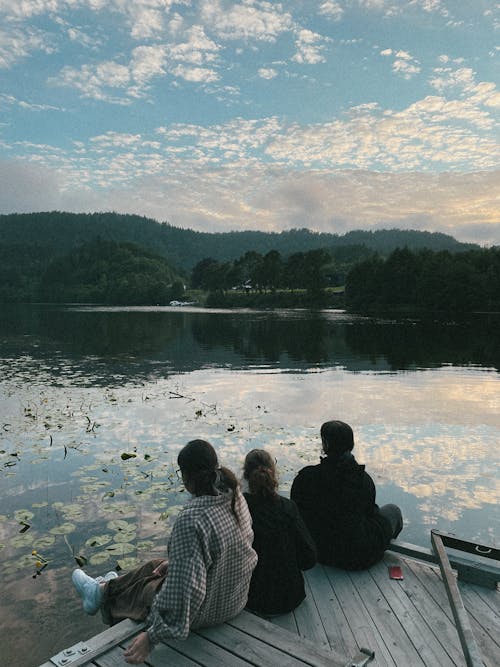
[225,612,349,667]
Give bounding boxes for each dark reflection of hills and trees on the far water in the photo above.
[0,307,500,383]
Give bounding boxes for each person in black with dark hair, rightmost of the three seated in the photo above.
[290,421,403,570]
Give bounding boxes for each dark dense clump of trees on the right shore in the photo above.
[346,247,500,312]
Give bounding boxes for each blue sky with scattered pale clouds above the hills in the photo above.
[0,0,500,245]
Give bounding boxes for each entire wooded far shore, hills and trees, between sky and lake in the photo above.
[0,212,500,312]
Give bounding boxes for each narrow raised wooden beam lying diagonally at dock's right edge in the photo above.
[431,531,483,667]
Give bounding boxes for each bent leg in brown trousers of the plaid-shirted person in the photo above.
[101,559,166,625]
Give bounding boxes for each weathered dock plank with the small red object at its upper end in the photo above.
[370,562,455,667]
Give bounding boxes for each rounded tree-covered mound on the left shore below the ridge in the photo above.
[39,239,179,304]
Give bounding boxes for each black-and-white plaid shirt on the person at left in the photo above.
[146,489,257,644]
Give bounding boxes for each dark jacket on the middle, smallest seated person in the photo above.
[244,493,316,615]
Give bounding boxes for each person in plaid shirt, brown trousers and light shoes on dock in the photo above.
[73,440,257,664]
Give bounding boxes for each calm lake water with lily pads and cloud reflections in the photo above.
[0,307,500,667]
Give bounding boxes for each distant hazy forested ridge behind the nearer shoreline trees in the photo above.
[0,211,475,271]
